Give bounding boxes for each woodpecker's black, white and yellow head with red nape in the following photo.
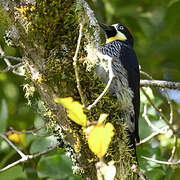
[99,23,134,47]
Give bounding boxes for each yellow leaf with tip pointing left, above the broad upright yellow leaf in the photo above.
[54,97,87,126]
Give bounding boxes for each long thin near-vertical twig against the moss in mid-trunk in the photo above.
[73,23,85,107]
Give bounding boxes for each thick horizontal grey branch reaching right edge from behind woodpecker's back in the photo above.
[140,80,180,90]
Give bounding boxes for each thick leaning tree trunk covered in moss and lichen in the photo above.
[0,0,138,180]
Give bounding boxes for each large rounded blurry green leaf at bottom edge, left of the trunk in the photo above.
[37,152,73,180]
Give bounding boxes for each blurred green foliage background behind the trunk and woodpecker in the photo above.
[0,0,180,180]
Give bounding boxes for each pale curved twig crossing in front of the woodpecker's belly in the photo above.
[87,58,115,110]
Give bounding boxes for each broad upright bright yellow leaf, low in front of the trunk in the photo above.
[88,123,114,158]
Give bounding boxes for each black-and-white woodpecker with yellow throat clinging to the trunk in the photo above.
[96,23,140,152]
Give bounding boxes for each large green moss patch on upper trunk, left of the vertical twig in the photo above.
[13,0,79,96]
